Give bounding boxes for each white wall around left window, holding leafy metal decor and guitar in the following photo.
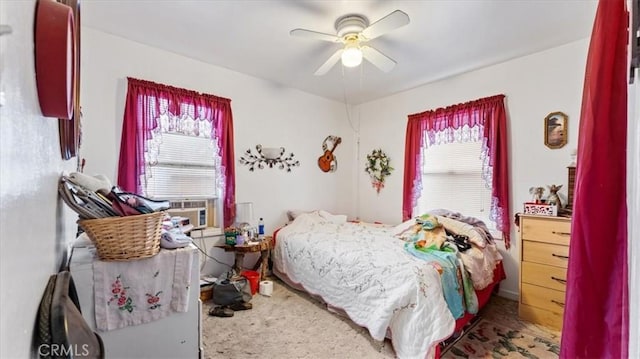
[81,27,354,274]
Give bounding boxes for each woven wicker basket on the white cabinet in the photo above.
[78,212,164,261]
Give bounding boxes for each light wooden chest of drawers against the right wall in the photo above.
[518,215,571,330]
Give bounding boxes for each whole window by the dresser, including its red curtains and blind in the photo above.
[402,95,511,249]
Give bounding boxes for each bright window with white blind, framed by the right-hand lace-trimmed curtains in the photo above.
[413,141,495,229]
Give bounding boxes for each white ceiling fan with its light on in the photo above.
[289,10,409,76]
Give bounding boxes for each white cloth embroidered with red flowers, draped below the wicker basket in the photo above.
[93,246,195,331]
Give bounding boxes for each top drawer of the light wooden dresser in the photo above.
[522,217,571,246]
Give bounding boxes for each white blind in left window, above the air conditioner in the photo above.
[146,133,216,199]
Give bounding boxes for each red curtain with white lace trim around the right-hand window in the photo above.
[402,95,511,248]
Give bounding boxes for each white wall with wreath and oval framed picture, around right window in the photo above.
[358,40,588,298]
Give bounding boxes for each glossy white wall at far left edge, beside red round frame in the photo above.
[0,0,76,358]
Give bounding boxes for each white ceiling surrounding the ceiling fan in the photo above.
[81,0,597,104]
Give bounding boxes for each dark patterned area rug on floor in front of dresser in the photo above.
[442,319,560,359]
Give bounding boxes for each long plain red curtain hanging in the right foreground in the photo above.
[560,0,629,358]
